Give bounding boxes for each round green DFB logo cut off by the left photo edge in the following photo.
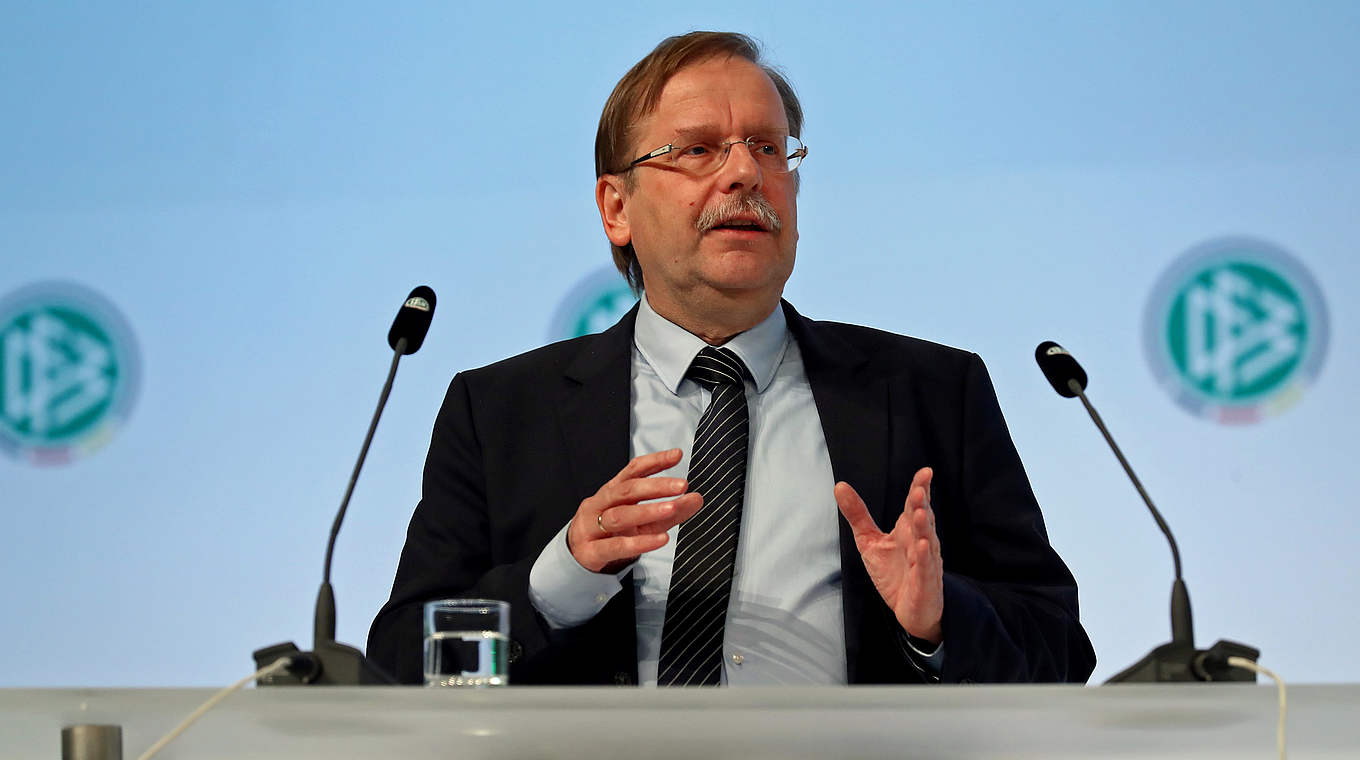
[0,283,139,465]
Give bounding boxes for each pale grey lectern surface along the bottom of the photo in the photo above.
[0,684,1360,760]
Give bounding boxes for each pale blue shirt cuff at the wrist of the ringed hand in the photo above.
[529,522,632,629]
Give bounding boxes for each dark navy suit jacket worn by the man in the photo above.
[369,302,1095,684]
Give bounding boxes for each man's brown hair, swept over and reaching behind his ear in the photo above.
[596,31,802,292]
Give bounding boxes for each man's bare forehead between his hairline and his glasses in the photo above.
[636,56,789,137]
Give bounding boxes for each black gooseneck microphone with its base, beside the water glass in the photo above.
[253,286,435,687]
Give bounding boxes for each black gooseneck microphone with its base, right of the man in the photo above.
[1034,340,1261,684]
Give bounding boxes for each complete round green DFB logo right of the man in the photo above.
[1144,238,1327,424]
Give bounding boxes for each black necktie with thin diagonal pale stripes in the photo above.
[657,347,751,687]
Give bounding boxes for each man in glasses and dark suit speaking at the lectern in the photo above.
[369,33,1095,685]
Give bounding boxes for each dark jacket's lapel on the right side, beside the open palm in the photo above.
[783,302,892,683]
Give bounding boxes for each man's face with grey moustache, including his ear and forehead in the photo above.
[598,57,798,313]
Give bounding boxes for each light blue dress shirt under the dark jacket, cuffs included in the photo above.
[529,298,940,685]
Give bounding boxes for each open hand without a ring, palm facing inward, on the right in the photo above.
[835,468,944,643]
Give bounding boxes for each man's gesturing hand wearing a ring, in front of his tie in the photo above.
[567,449,703,572]
